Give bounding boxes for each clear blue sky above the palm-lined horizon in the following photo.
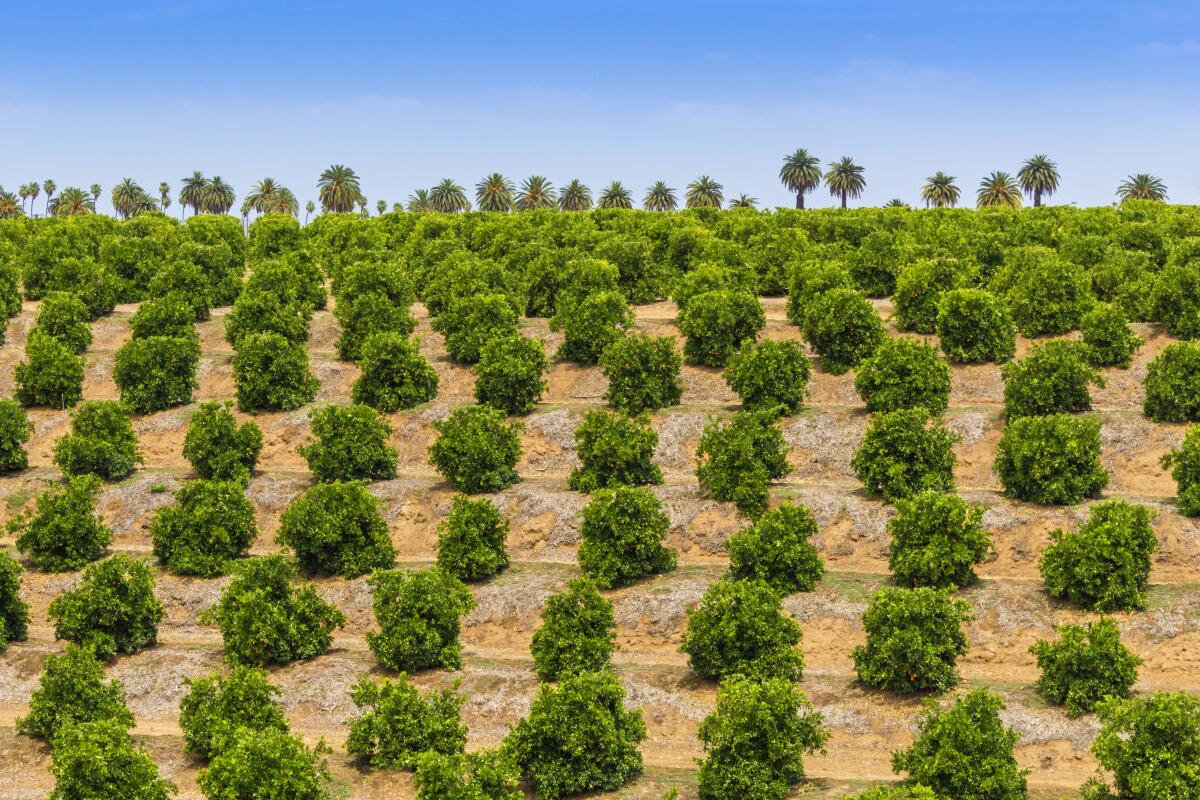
[0,0,1200,207]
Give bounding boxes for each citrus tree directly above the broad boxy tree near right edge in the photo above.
[1001,339,1104,420]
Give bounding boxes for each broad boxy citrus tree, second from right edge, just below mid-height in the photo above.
[994,414,1109,505]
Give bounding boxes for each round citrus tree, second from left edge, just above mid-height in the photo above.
[113,336,200,414]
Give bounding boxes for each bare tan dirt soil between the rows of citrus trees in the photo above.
[0,299,1200,800]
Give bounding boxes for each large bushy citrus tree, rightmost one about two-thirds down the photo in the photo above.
[1038,500,1158,613]
